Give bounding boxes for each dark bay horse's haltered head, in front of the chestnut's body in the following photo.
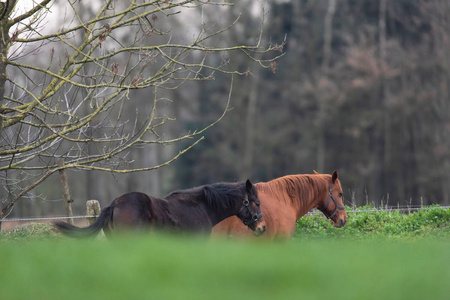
[237,179,266,235]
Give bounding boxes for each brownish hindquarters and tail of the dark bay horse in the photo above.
[53,192,152,237]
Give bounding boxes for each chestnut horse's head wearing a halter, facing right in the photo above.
[318,171,347,227]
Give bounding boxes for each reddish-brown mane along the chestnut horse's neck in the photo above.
[255,174,331,202]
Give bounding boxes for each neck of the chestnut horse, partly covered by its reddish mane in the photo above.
[256,174,330,220]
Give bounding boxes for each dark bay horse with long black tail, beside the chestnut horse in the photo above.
[54,180,265,237]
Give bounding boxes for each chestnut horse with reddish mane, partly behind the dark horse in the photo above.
[212,171,347,239]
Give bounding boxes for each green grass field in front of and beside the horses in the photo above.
[0,209,450,299]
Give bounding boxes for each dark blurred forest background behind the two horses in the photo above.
[7,0,450,216]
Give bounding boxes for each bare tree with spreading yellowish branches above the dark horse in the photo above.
[0,0,277,218]
